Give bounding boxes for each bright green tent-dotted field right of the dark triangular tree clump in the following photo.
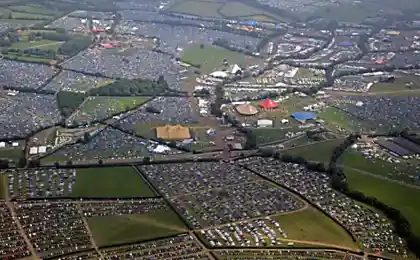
[79,96,149,115]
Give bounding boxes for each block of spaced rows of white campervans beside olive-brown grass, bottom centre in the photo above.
[201,217,287,247]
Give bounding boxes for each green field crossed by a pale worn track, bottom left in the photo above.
[88,211,186,246]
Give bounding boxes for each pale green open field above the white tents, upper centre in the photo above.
[181,44,246,73]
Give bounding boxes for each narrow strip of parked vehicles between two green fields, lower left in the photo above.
[79,198,168,217]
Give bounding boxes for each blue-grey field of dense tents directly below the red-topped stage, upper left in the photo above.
[63,49,181,90]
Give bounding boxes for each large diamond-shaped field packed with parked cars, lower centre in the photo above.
[142,162,304,228]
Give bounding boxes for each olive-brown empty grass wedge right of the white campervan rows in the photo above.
[274,207,357,249]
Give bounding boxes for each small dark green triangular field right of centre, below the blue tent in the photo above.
[286,139,343,163]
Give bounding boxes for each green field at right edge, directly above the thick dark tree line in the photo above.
[344,168,420,235]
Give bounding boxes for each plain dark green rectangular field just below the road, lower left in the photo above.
[71,167,155,198]
